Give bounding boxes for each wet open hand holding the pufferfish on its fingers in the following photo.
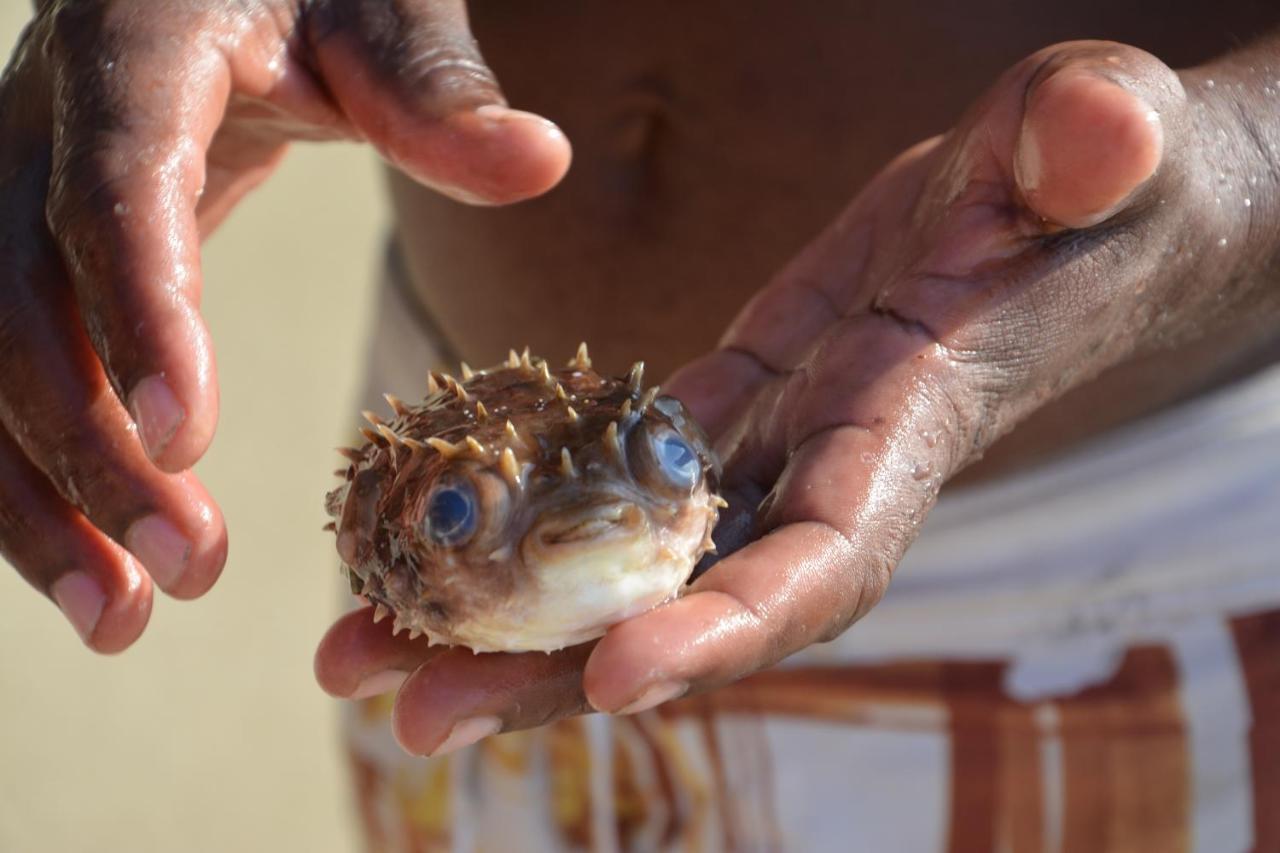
[316,42,1276,753]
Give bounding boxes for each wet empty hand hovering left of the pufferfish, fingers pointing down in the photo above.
[0,0,568,652]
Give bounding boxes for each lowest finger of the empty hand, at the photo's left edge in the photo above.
[0,433,151,653]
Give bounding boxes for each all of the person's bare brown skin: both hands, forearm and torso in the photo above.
[0,0,1280,753]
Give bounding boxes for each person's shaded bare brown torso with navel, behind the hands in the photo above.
[393,0,1280,473]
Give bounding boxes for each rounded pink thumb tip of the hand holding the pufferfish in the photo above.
[1012,42,1185,228]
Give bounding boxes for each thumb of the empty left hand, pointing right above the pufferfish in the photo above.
[311,0,570,204]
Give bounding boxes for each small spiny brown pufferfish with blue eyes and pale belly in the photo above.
[325,345,724,652]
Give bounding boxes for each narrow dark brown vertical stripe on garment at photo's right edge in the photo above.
[1231,610,1280,850]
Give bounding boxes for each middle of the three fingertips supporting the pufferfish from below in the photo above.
[392,644,591,756]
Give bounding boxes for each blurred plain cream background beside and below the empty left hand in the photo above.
[0,8,387,853]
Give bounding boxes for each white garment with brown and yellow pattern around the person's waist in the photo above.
[346,252,1280,853]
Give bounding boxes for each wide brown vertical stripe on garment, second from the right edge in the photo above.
[1057,646,1192,853]
